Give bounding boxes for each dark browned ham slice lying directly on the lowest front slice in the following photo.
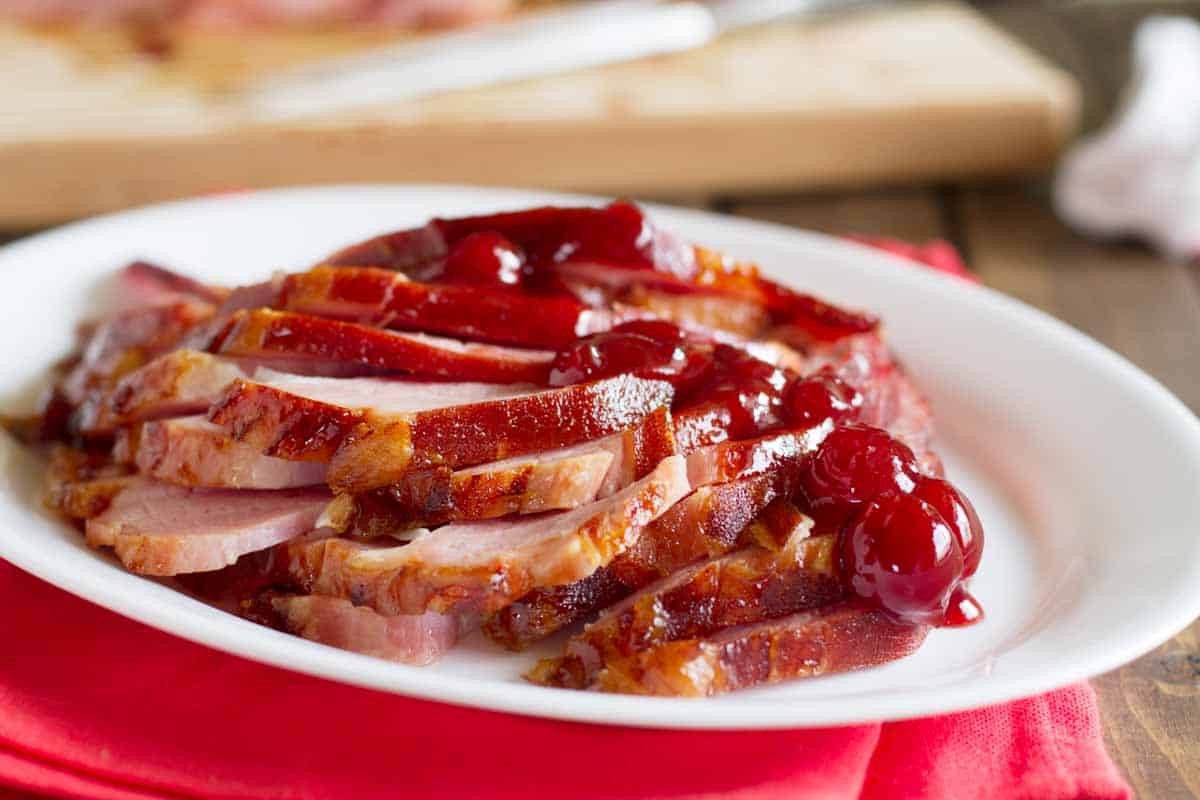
[533,532,846,688]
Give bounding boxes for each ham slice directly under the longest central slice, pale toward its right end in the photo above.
[325,408,674,536]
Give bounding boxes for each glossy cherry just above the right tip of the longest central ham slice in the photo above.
[550,320,689,386]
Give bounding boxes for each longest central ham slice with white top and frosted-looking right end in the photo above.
[209,375,672,493]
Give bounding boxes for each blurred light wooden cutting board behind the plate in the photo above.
[0,2,1078,227]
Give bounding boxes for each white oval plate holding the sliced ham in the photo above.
[0,187,1200,728]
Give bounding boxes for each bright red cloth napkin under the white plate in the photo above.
[0,236,1129,800]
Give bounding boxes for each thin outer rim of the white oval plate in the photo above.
[0,184,1200,730]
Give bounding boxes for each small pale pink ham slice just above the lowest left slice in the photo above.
[134,416,325,489]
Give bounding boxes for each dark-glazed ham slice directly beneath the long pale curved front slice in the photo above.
[484,473,798,650]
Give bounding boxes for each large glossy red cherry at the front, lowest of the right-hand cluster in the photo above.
[839,494,962,625]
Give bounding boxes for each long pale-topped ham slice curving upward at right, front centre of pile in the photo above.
[289,456,688,614]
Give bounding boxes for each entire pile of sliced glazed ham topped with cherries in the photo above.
[21,203,983,696]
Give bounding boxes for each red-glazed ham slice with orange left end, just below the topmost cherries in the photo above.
[277,266,616,350]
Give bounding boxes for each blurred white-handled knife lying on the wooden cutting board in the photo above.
[234,0,860,120]
